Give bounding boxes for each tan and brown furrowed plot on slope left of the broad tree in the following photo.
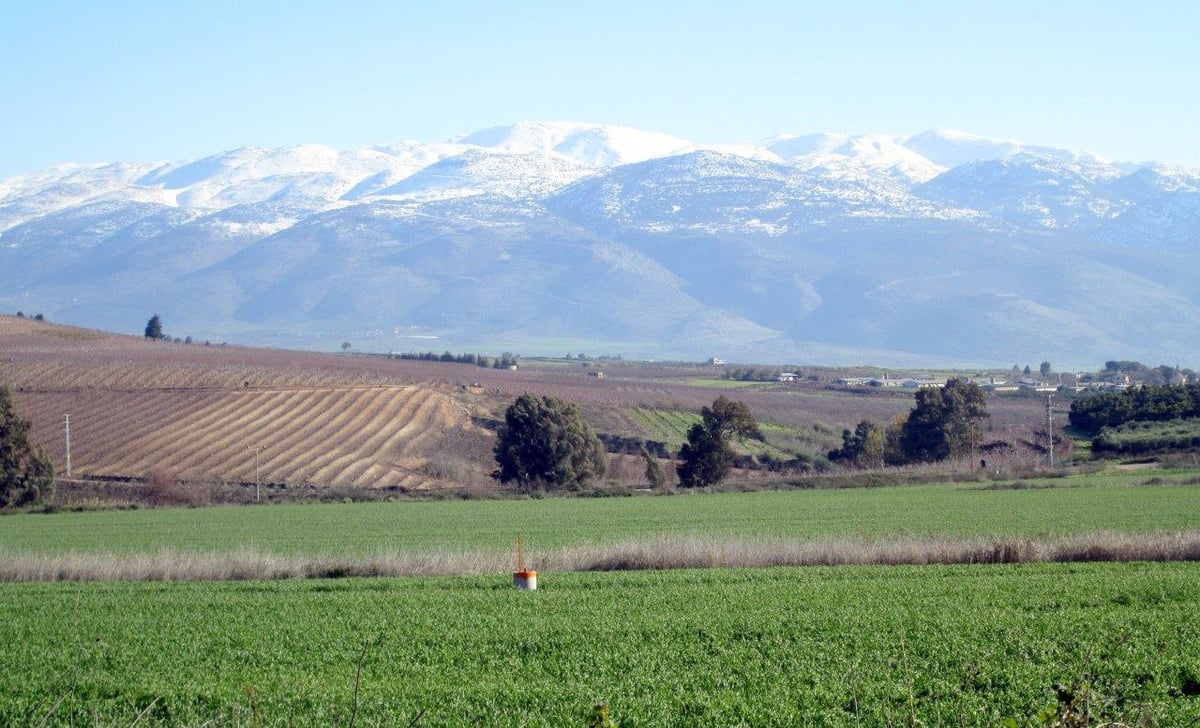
[22,385,482,489]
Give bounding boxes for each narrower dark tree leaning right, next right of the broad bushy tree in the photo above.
[677,395,762,488]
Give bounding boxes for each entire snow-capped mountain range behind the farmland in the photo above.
[0,122,1200,366]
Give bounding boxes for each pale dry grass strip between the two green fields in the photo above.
[0,531,1200,582]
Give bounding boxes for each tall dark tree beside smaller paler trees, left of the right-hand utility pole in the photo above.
[900,379,988,463]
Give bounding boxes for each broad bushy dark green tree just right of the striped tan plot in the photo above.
[493,395,607,489]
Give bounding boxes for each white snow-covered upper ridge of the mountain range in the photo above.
[0,121,1200,239]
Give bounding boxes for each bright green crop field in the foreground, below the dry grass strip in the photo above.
[0,564,1200,727]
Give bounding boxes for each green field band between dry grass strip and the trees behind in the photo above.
[0,471,1200,554]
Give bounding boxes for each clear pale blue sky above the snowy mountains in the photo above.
[0,0,1200,176]
